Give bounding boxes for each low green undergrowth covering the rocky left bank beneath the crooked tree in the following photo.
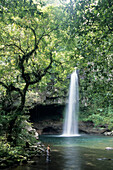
[0,114,39,168]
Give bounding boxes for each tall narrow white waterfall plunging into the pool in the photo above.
[63,70,79,136]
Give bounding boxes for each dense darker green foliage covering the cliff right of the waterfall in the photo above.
[63,0,113,127]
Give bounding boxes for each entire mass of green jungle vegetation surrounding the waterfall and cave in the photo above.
[0,0,113,166]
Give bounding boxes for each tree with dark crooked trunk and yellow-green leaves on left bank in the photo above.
[0,1,69,141]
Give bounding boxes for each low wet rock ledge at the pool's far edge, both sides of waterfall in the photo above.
[34,120,107,135]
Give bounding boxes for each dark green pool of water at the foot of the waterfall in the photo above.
[13,135,113,170]
